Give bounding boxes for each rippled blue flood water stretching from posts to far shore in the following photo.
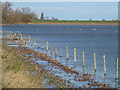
[2,25,120,87]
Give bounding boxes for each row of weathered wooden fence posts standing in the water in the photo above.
[4,32,119,81]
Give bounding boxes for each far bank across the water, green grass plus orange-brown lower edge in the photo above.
[30,20,118,25]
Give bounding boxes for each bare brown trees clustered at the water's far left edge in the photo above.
[0,2,37,24]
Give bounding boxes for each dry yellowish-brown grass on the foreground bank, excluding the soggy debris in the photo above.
[2,45,44,88]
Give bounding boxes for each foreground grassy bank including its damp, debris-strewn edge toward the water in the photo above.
[2,41,67,88]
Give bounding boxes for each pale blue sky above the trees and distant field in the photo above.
[7,2,118,20]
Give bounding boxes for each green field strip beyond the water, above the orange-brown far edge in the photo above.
[32,20,118,23]
